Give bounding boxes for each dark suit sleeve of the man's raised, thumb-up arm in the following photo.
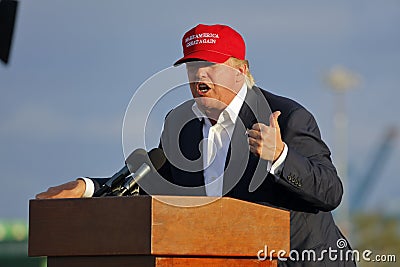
[277,108,343,211]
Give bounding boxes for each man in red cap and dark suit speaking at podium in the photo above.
[37,24,355,266]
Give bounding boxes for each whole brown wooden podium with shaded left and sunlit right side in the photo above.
[28,196,290,267]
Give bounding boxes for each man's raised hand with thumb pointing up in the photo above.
[247,111,284,162]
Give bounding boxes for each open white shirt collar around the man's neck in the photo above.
[192,83,247,123]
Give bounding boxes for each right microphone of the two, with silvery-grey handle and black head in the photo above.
[113,148,166,196]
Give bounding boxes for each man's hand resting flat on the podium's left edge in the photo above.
[36,179,86,199]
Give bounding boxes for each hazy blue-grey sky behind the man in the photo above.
[0,0,400,221]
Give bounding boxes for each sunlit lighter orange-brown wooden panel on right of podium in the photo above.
[152,196,290,258]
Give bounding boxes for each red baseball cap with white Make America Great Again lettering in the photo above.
[174,24,246,66]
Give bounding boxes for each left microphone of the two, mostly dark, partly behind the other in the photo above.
[93,148,147,197]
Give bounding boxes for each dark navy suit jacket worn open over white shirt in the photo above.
[93,87,354,266]
